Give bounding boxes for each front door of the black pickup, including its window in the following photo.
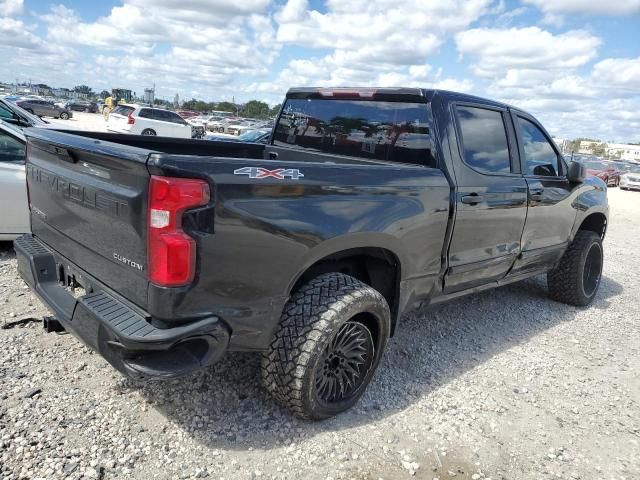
[512,111,577,272]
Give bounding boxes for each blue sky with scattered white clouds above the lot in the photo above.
[0,0,640,142]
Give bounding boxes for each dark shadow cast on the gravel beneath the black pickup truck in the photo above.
[122,277,623,450]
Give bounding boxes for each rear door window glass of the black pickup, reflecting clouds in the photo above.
[456,105,511,174]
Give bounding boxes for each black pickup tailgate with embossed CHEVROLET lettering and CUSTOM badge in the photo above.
[25,129,149,308]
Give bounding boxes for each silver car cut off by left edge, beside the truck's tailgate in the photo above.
[0,120,30,241]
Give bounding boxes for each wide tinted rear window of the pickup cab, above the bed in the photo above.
[273,98,437,167]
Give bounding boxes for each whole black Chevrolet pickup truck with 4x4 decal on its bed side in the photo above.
[15,88,608,419]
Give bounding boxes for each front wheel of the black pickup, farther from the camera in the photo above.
[547,230,604,307]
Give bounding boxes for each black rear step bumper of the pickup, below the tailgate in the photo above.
[14,234,229,378]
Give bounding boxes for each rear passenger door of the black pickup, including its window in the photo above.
[444,102,527,293]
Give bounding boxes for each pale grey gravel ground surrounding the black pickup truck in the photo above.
[0,189,640,480]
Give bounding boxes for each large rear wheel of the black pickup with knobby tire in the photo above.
[261,273,391,420]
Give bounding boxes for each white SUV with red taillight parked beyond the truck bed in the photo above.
[107,105,194,138]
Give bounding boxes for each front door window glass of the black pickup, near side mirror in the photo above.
[518,117,560,177]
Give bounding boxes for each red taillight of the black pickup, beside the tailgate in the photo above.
[147,175,210,287]
